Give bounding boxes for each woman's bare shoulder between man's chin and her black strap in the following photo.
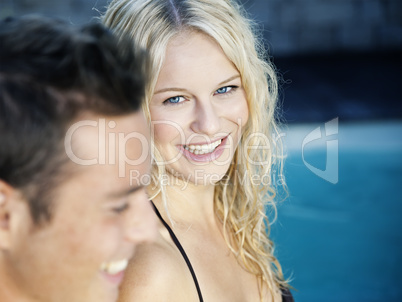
[118,232,197,302]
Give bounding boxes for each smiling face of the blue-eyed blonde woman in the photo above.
[150,32,248,185]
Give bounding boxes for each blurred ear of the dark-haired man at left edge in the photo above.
[0,179,26,250]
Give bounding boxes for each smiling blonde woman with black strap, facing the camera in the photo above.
[103,0,293,302]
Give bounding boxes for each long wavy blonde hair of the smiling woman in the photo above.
[102,0,287,294]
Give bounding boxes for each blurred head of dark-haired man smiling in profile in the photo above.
[0,17,155,302]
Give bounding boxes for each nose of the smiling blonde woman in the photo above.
[191,99,221,137]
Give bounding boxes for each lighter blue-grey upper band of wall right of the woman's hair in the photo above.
[242,0,402,55]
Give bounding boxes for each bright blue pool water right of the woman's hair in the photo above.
[272,122,402,302]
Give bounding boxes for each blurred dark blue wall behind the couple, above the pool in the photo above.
[0,0,402,123]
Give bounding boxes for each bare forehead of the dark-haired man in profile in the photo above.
[64,111,150,182]
